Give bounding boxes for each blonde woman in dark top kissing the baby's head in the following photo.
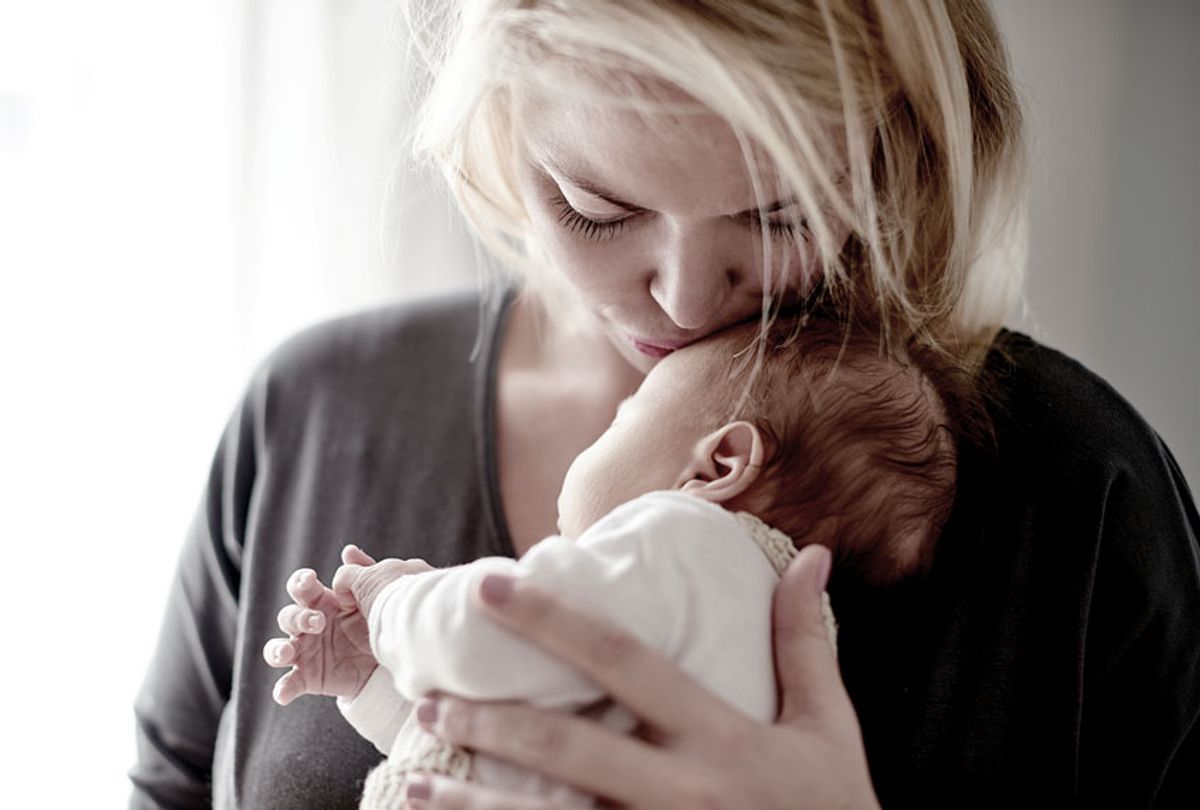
[133,0,1200,808]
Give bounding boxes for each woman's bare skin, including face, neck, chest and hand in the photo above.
[267,84,878,810]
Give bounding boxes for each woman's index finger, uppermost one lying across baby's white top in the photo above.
[470,575,744,734]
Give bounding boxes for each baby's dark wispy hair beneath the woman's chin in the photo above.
[707,317,973,584]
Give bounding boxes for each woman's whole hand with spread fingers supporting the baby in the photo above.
[408,545,878,810]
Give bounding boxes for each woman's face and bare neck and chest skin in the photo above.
[497,82,847,556]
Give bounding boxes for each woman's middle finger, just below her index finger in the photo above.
[416,696,685,806]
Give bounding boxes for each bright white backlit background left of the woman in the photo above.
[0,0,474,808]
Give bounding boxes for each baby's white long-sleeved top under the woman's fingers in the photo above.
[370,493,776,715]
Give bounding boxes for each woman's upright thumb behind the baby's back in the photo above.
[773,544,850,724]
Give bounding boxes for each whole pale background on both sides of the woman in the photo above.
[0,0,1200,806]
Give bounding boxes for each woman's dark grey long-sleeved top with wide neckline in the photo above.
[131,295,1200,810]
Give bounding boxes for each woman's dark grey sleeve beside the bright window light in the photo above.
[130,388,256,810]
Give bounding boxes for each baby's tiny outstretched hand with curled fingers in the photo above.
[263,546,379,706]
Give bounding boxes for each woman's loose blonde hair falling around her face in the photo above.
[398,0,1026,362]
